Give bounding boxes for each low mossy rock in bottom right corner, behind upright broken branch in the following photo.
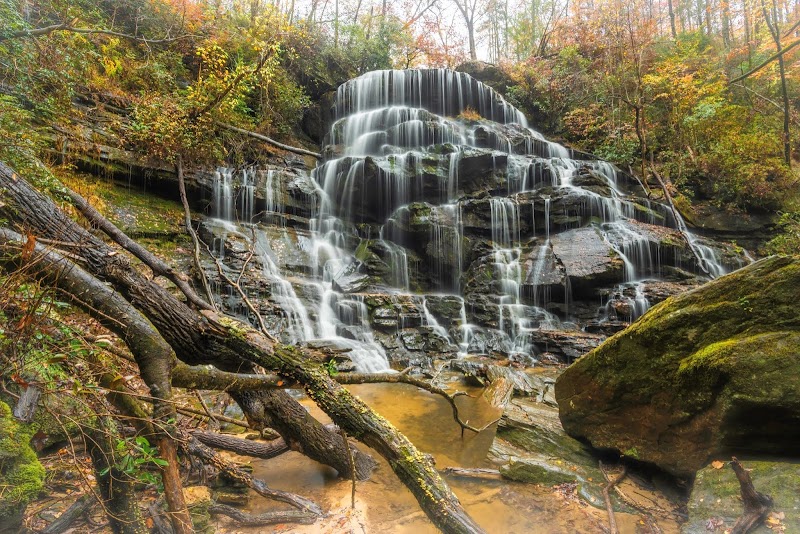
[682,459,800,534]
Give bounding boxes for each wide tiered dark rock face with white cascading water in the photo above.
[198,69,744,369]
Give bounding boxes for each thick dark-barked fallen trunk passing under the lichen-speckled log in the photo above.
[0,163,374,486]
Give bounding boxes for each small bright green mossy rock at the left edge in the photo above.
[0,401,44,532]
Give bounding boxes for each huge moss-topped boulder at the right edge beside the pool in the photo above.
[556,257,800,476]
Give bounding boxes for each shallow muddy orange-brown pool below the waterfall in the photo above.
[218,384,677,534]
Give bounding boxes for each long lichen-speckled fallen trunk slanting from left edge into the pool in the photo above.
[0,164,483,533]
